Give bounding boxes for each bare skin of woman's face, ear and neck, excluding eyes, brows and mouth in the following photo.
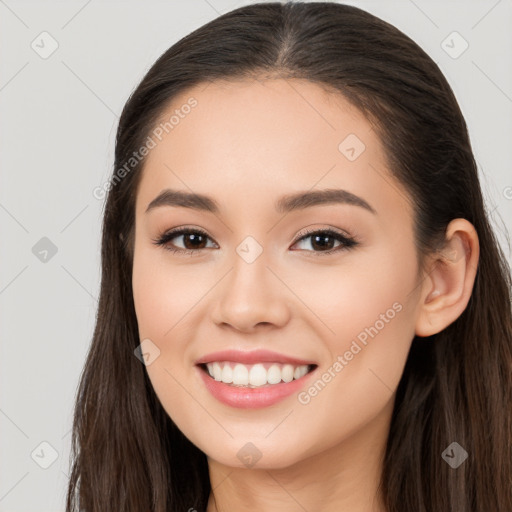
[133,79,479,512]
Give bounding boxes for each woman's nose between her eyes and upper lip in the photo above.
[212,251,290,333]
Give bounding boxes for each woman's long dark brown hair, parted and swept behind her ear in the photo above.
[66,2,512,512]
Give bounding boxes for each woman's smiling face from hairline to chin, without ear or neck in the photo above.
[133,79,420,468]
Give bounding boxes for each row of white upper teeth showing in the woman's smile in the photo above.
[197,361,317,389]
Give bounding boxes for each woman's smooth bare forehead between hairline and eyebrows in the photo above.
[137,79,410,220]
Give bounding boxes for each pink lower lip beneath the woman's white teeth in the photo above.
[197,366,316,409]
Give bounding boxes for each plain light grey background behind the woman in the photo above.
[0,0,512,512]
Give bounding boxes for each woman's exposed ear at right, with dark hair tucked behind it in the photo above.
[415,219,480,336]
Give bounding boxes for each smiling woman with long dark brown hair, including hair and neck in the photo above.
[67,2,512,512]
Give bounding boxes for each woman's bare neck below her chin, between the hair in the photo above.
[207,397,394,512]
